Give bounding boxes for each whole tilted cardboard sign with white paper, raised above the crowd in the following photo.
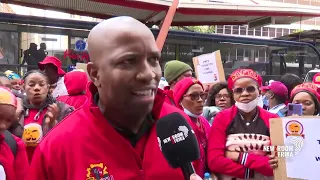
[193,50,225,86]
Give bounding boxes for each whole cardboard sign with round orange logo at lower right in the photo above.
[270,116,320,180]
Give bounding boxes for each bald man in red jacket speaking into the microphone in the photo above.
[29,17,202,180]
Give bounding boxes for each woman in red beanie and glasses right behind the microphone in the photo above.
[173,78,210,177]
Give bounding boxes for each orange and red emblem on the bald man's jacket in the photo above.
[86,163,114,180]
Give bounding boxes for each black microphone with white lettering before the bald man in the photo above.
[156,112,200,180]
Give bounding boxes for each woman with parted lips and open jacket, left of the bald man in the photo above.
[19,70,73,162]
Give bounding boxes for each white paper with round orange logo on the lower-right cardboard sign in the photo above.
[282,117,320,180]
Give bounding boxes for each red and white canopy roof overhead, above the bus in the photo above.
[2,0,320,26]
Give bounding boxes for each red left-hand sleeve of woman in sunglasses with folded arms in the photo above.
[207,112,253,179]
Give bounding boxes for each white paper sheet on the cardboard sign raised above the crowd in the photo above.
[196,53,219,84]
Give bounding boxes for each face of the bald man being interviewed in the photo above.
[89,28,161,114]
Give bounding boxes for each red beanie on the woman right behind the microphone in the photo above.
[173,77,204,109]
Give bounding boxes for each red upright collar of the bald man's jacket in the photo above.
[86,82,166,120]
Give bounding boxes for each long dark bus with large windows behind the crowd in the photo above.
[0,13,320,81]
